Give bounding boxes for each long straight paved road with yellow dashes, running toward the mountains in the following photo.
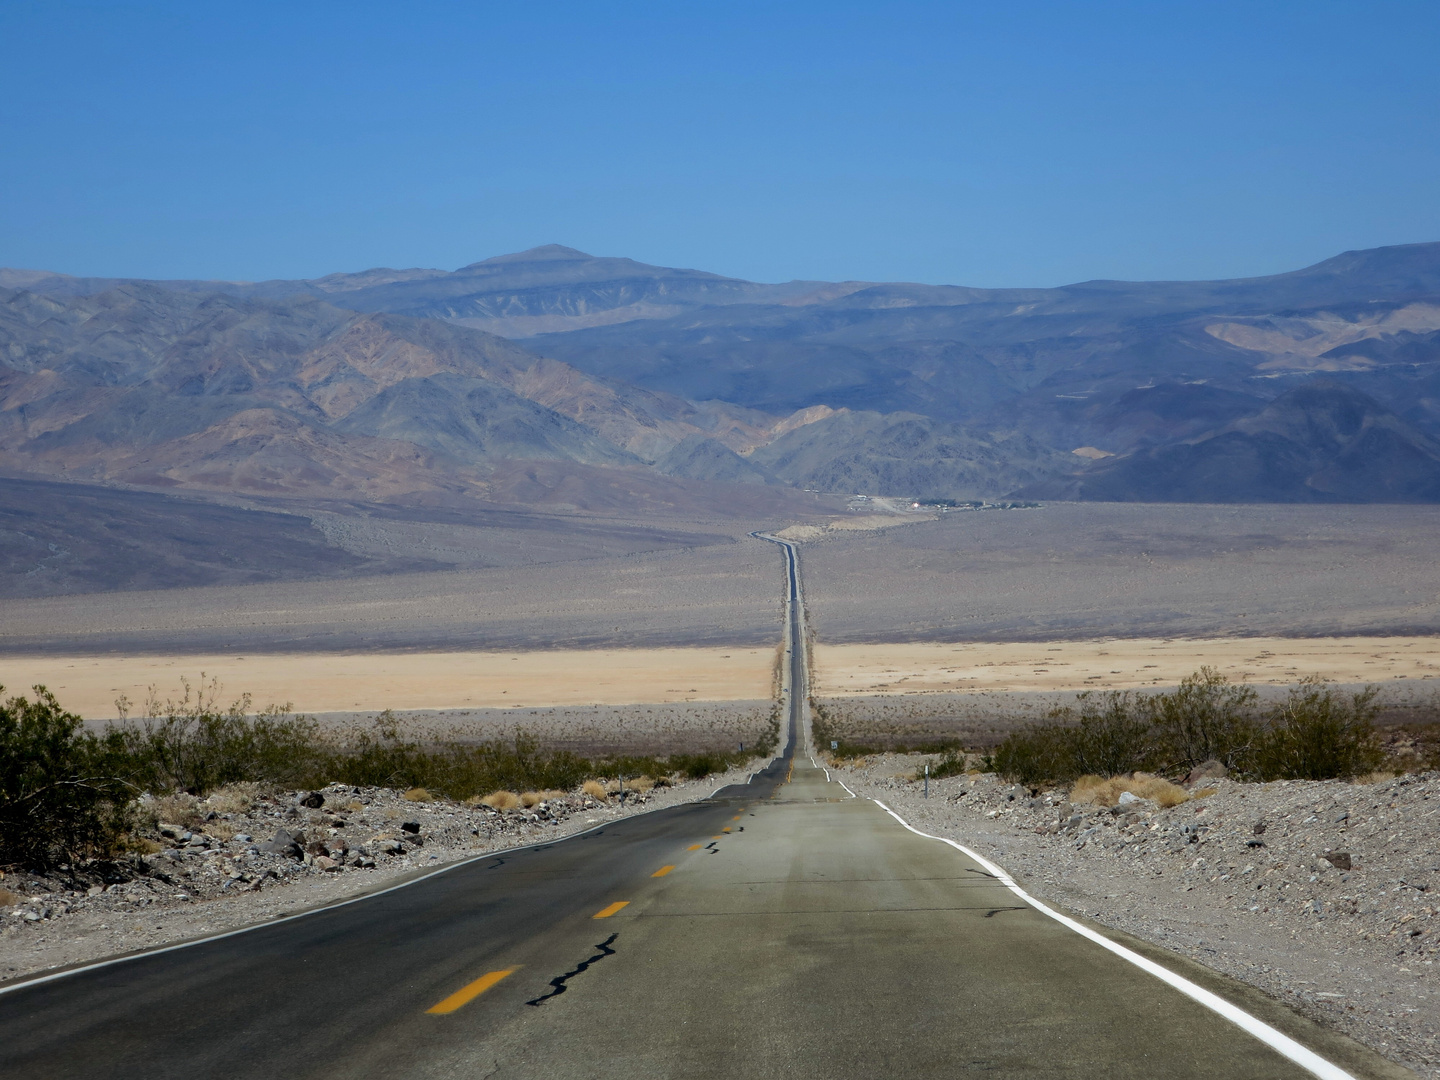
[0,538,1394,1080]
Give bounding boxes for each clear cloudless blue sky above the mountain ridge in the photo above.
[0,0,1440,287]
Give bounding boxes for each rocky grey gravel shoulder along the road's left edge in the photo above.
[0,762,762,986]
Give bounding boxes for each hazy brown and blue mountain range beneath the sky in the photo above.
[0,243,1440,513]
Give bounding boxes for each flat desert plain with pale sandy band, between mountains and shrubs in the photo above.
[8,503,1440,727]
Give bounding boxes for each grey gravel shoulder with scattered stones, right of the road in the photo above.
[837,755,1440,1077]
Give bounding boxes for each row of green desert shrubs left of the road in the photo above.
[0,680,779,868]
